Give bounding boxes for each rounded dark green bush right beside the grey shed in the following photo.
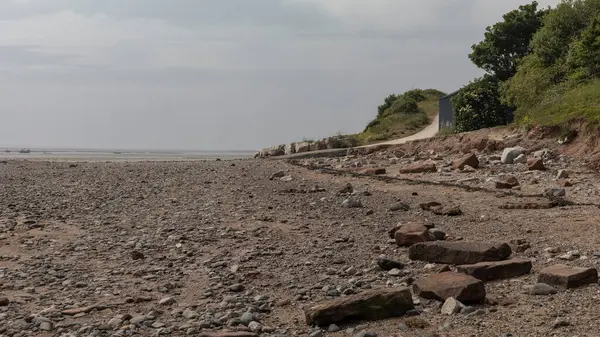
[452,75,507,132]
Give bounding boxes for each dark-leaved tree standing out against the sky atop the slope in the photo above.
[469,1,548,81]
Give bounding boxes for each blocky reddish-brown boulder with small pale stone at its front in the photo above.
[413,271,485,303]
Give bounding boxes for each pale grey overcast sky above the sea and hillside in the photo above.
[0,0,556,150]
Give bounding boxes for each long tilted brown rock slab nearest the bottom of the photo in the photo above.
[304,288,414,326]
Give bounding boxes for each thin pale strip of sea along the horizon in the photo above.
[0,147,256,161]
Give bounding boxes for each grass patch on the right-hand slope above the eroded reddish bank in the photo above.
[518,80,600,126]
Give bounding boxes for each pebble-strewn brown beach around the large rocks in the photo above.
[0,137,600,337]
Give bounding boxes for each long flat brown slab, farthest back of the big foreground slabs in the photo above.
[408,241,512,265]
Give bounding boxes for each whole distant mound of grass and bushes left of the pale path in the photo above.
[356,89,445,144]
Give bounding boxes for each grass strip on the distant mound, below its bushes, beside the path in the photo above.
[356,90,444,144]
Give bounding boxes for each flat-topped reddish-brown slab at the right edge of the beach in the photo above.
[538,264,598,288]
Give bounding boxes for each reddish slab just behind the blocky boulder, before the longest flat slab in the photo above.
[456,258,533,282]
